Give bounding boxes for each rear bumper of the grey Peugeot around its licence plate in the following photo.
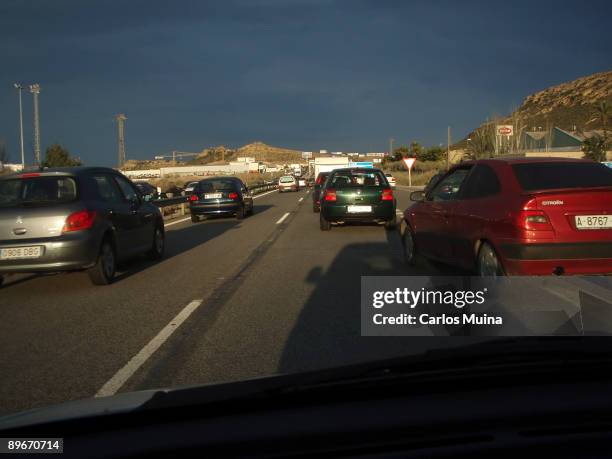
[0,231,101,273]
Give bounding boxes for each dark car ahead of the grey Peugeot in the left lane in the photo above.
[189,177,254,223]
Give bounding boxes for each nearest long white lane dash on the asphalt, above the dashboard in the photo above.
[95,300,202,397]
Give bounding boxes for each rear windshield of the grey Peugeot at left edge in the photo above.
[0,176,77,207]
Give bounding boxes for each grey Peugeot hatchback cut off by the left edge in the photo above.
[0,167,165,285]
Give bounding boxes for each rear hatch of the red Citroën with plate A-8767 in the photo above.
[513,161,612,242]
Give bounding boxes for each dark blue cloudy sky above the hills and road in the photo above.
[0,0,612,165]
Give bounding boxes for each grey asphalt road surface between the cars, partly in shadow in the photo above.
[0,190,482,414]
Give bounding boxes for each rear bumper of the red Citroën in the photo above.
[500,241,612,275]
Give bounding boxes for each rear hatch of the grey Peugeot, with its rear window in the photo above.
[0,173,80,243]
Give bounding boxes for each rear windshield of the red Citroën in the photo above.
[512,162,612,191]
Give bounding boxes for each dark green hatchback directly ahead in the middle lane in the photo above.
[319,168,396,231]
